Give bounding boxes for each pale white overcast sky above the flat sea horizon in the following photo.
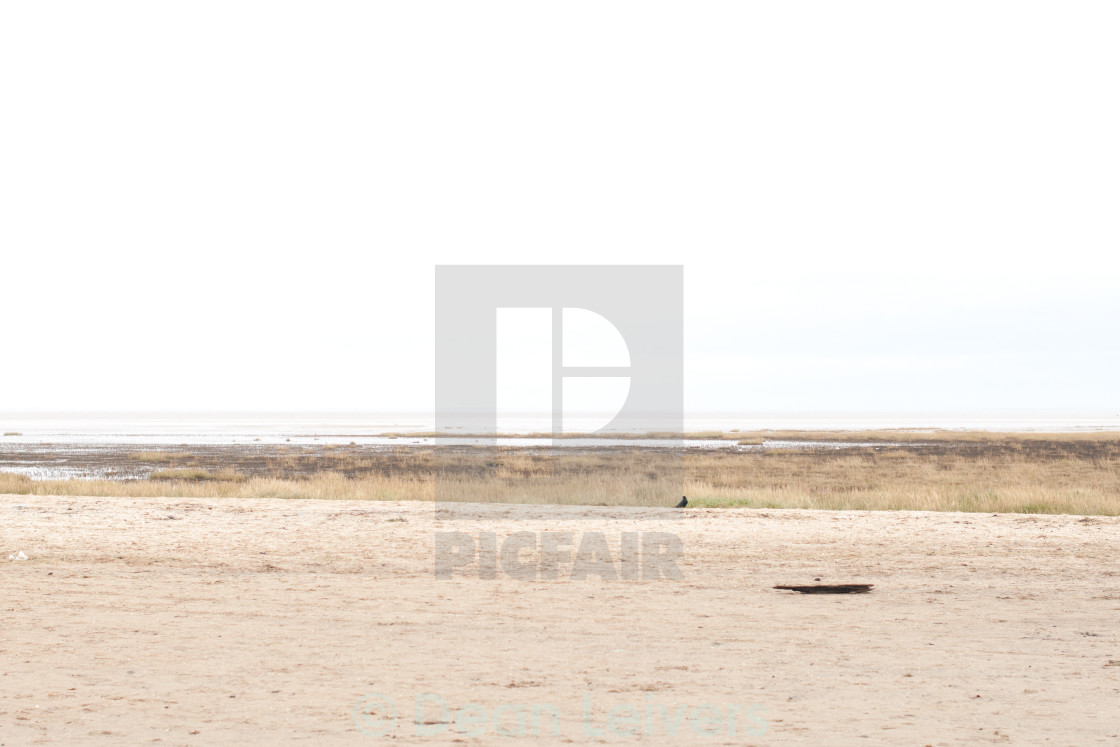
[0,1,1120,412]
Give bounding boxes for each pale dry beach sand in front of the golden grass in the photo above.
[0,496,1120,745]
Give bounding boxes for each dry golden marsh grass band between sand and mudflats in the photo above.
[0,431,1120,515]
